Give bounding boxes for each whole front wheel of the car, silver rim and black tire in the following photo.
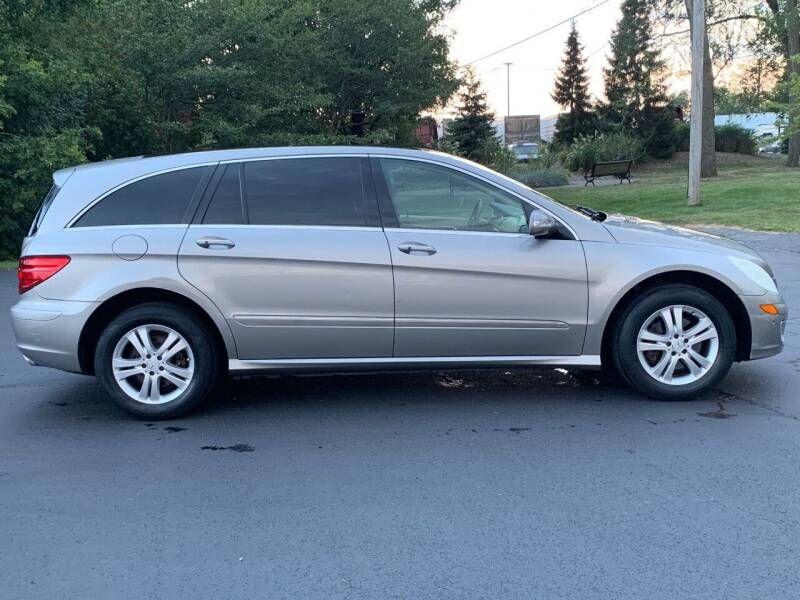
[611,285,736,400]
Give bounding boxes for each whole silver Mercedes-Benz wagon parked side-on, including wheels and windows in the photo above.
[11,147,787,419]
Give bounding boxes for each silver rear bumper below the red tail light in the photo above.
[11,291,97,373]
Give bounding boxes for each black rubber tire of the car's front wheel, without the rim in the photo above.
[609,284,736,400]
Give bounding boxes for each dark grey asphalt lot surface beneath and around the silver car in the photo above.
[0,231,800,599]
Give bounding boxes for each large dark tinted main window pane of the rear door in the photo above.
[244,157,366,225]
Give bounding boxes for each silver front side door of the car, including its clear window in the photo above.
[373,158,587,357]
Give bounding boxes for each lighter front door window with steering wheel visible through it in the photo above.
[380,158,528,233]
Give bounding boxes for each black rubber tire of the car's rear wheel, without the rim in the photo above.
[94,302,220,420]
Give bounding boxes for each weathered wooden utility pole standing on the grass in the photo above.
[688,0,706,206]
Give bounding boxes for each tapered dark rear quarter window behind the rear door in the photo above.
[75,167,209,227]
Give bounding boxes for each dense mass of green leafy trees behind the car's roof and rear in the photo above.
[0,0,458,258]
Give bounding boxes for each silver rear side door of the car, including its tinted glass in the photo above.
[179,156,394,359]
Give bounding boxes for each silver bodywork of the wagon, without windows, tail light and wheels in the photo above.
[11,147,787,372]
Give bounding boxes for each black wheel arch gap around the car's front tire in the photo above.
[600,270,752,365]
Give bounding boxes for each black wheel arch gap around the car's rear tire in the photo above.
[78,287,236,375]
